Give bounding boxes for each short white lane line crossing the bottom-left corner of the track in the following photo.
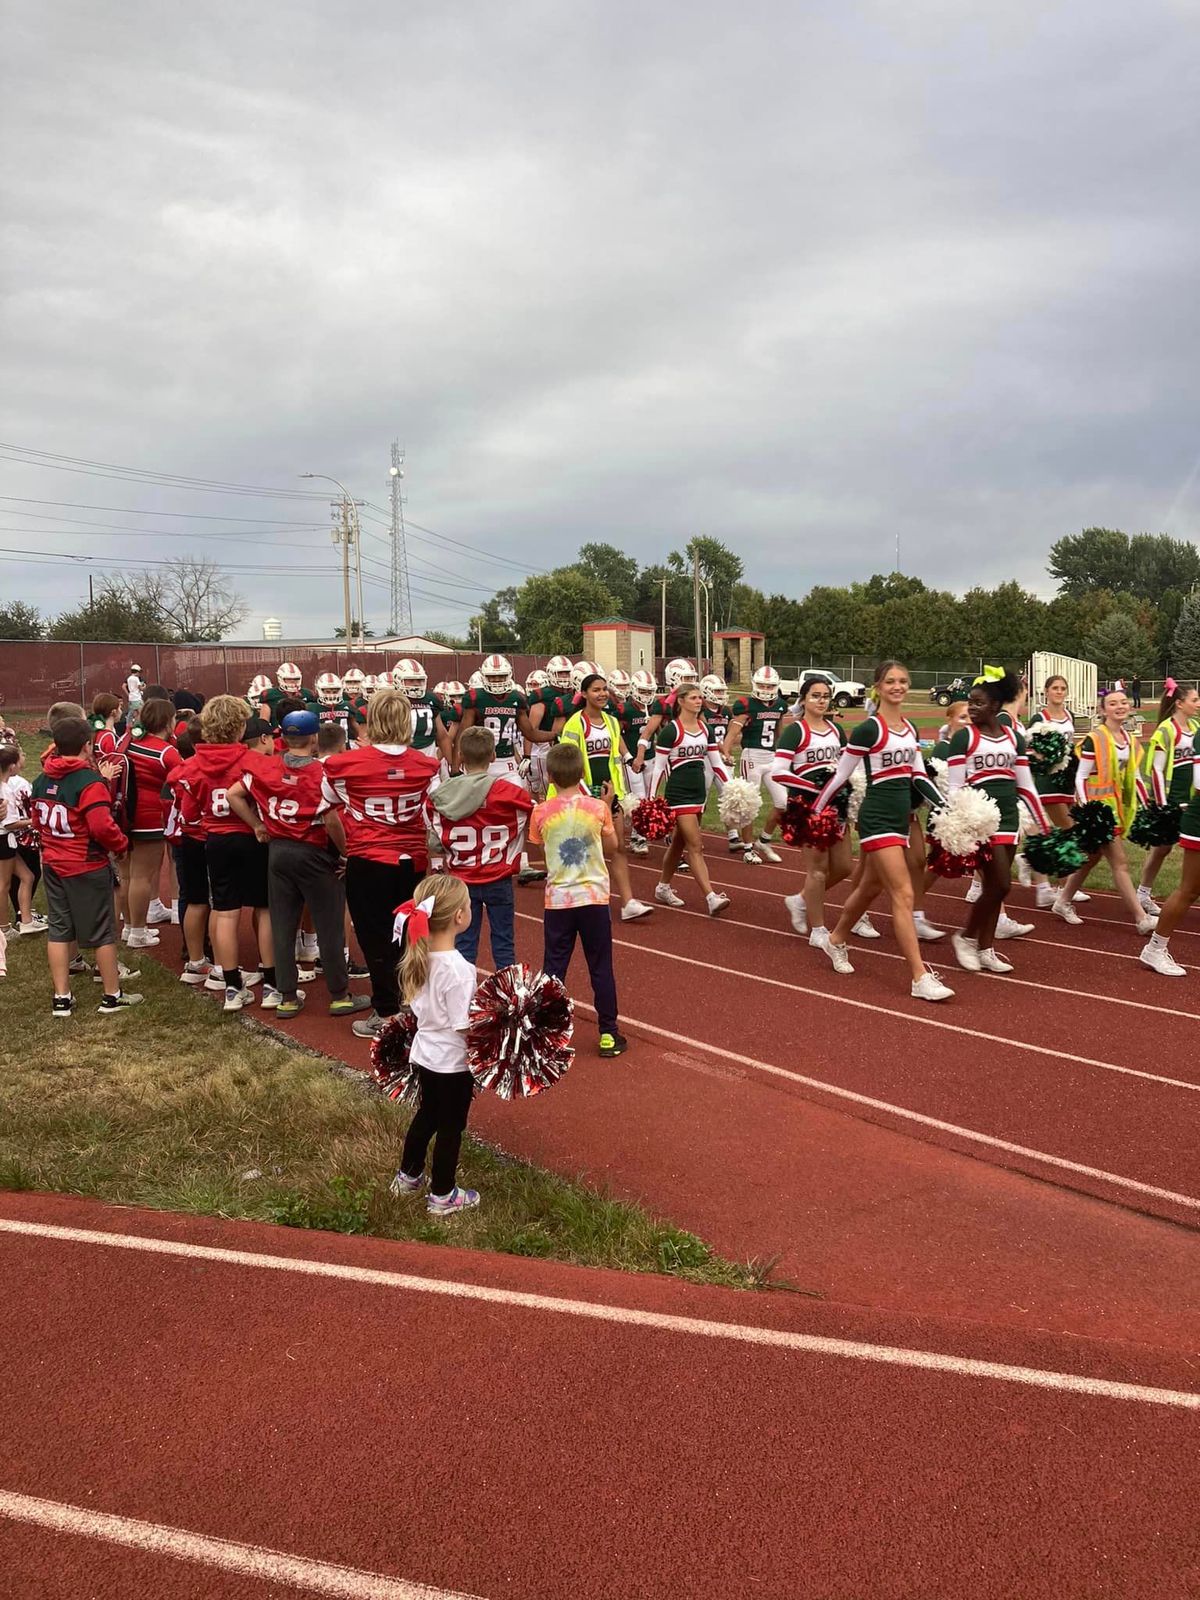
[0,1484,483,1600]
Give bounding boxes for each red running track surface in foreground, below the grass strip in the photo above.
[0,1195,1200,1600]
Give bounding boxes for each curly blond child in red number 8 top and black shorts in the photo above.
[174,694,278,1011]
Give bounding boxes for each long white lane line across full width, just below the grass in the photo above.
[0,1218,1200,1408]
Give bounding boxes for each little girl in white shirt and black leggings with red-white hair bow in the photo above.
[392,874,478,1216]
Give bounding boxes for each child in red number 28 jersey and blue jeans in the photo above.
[432,728,533,966]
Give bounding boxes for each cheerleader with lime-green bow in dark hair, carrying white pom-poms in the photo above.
[947,672,1048,973]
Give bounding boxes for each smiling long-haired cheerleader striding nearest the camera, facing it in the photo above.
[813,661,954,1000]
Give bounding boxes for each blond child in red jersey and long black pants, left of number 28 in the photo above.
[325,690,438,1038]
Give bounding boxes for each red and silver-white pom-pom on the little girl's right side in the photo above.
[467,962,574,1099]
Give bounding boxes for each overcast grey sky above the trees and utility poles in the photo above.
[0,0,1200,635]
